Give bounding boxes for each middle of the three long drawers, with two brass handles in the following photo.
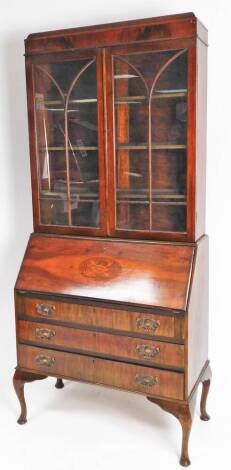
[18,320,184,368]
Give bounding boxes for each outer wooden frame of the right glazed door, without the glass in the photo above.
[104,38,196,241]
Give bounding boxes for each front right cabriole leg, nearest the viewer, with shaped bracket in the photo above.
[147,393,196,467]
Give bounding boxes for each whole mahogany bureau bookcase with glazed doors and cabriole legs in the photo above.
[14,13,211,466]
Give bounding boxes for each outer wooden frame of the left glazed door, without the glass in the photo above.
[26,49,106,236]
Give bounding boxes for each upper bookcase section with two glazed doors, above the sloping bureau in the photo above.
[26,13,207,242]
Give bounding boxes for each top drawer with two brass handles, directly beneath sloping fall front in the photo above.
[16,296,184,339]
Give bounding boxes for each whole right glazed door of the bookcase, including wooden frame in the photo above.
[104,39,196,241]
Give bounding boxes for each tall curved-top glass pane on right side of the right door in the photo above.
[151,52,187,232]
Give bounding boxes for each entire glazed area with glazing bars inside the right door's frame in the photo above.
[114,51,187,232]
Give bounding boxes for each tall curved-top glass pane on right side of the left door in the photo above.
[68,62,99,227]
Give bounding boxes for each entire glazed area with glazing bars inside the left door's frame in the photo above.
[35,58,100,227]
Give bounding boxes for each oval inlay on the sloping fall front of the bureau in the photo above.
[79,256,121,281]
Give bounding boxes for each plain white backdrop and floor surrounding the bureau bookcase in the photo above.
[0,0,231,470]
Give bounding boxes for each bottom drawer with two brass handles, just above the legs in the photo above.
[18,345,184,400]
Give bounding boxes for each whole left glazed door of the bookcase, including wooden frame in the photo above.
[27,51,105,235]
